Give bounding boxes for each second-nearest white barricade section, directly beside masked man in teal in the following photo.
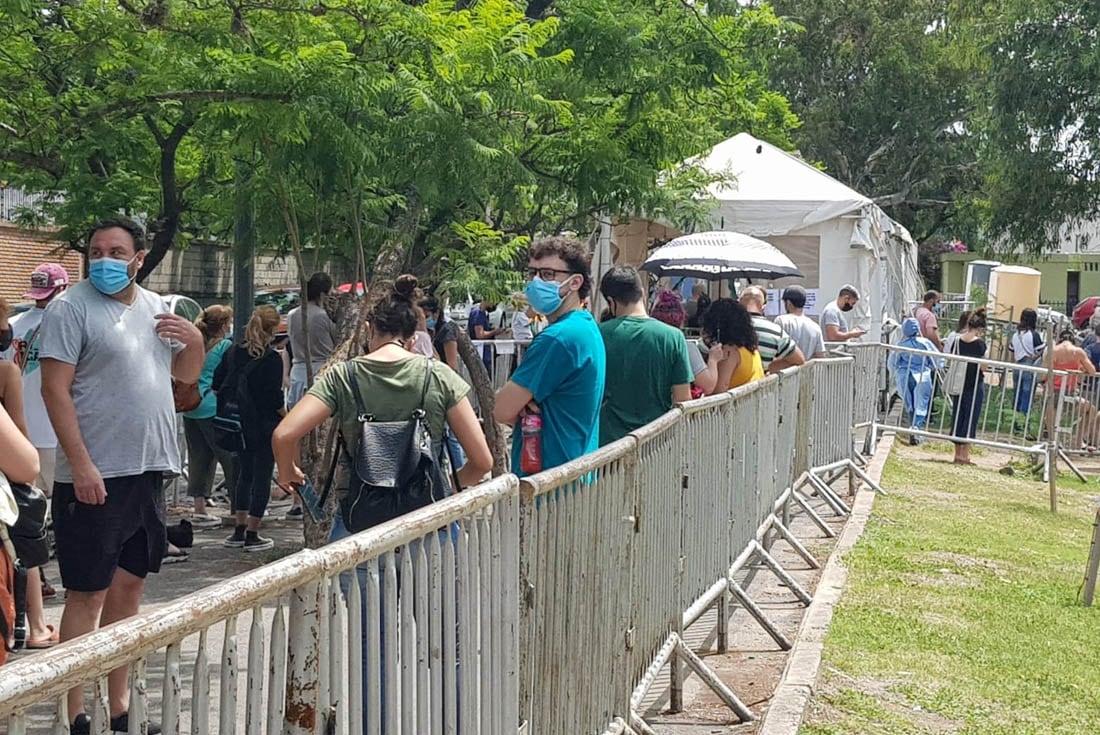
[519,437,639,735]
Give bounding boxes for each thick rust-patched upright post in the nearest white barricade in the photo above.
[283,580,322,735]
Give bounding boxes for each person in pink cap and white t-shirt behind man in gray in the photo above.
[3,263,69,494]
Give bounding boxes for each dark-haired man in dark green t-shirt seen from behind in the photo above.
[600,266,692,447]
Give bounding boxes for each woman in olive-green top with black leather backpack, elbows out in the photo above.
[274,275,493,530]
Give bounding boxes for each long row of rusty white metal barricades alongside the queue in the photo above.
[0,358,858,735]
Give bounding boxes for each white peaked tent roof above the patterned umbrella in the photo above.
[692,133,871,237]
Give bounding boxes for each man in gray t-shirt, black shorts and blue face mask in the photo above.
[39,220,206,735]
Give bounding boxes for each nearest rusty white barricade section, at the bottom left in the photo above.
[0,475,519,735]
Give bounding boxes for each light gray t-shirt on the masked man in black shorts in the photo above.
[39,281,183,482]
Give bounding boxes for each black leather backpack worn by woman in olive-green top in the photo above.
[332,358,448,534]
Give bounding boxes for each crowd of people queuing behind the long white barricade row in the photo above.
[0,220,862,733]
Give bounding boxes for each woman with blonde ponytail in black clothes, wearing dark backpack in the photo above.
[211,306,286,551]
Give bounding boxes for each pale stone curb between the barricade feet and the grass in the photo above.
[757,434,894,735]
